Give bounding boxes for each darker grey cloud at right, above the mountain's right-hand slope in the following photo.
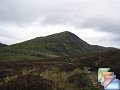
[82,18,120,34]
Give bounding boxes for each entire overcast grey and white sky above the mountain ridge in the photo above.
[0,0,120,48]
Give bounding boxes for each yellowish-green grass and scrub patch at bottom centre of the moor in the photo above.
[40,67,98,90]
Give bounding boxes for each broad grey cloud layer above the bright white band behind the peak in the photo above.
[0,0,120,47]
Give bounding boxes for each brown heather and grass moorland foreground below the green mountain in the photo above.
[0,50,120,90]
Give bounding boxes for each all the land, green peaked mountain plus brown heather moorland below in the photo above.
[0,32,120,90]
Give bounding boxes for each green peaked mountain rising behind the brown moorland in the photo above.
[0,31,115,61]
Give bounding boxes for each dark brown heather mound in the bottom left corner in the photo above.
[0,74,54,90]
